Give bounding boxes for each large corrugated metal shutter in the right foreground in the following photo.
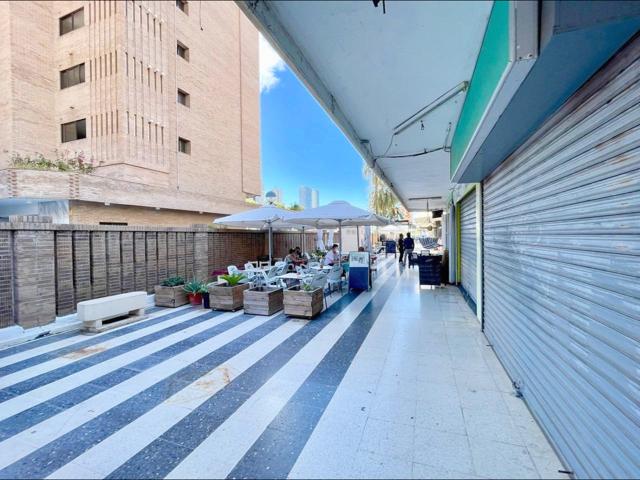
[483,42,640,478]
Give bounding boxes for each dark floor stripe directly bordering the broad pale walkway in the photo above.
[227,264,396,479]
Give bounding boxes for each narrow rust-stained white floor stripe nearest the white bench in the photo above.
[0,310,203,388]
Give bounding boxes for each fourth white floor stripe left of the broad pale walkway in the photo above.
[0,312,245,420]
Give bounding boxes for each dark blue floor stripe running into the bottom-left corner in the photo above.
[0,304,340,479]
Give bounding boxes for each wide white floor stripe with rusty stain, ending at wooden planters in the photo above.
[48,321,305,479]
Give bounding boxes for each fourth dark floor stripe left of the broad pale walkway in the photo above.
[0,314,254,442]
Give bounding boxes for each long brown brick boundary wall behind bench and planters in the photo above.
[0,217,314,328]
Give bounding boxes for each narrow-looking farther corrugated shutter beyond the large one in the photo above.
[460,188,478,302]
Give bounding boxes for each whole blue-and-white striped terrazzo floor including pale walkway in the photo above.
[0,257,557,479]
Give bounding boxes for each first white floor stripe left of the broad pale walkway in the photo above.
[167,264,398,479]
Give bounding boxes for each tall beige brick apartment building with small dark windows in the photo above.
[0,0,261,225]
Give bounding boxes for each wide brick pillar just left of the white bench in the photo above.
[13,230,56,328]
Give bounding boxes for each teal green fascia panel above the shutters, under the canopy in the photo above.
[450,0,509,177]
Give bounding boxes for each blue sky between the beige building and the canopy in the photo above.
[260,39,368,208]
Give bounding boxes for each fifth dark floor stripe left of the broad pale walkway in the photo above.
[0,310,223,396]
